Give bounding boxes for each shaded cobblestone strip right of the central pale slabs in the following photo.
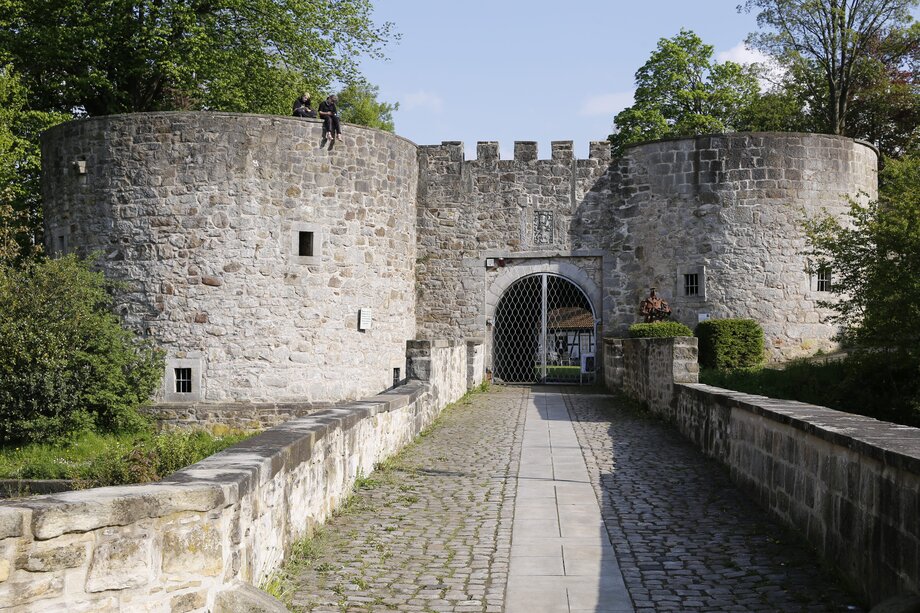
[565,390,862,612]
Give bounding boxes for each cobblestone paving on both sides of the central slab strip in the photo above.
[288,388,860,613]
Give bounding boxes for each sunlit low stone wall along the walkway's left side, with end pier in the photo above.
[0,341,478,612]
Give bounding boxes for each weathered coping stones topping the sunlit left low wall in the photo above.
[0,381,428,540]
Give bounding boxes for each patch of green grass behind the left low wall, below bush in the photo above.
[0,430,249,487]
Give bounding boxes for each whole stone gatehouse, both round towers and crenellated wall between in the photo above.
[42,113,877,402]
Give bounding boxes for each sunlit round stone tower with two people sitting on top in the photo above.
[42,112,418,402]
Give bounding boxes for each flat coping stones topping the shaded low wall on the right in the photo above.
[678,383,920,473]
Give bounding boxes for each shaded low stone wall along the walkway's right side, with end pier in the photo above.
[605,338,920,604]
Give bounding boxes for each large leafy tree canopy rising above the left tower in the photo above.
[0,0,394,115]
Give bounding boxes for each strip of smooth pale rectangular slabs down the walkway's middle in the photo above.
[505,388,633,613]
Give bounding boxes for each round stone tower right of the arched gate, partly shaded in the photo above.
[610,133,878,359]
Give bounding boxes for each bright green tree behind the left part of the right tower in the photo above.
[610,30,759,154]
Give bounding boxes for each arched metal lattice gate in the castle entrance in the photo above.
[492,273,597,383]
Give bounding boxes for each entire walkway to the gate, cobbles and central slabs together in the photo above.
[289,387,859,613]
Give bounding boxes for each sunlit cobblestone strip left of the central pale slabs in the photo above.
[293,388,529,612]
